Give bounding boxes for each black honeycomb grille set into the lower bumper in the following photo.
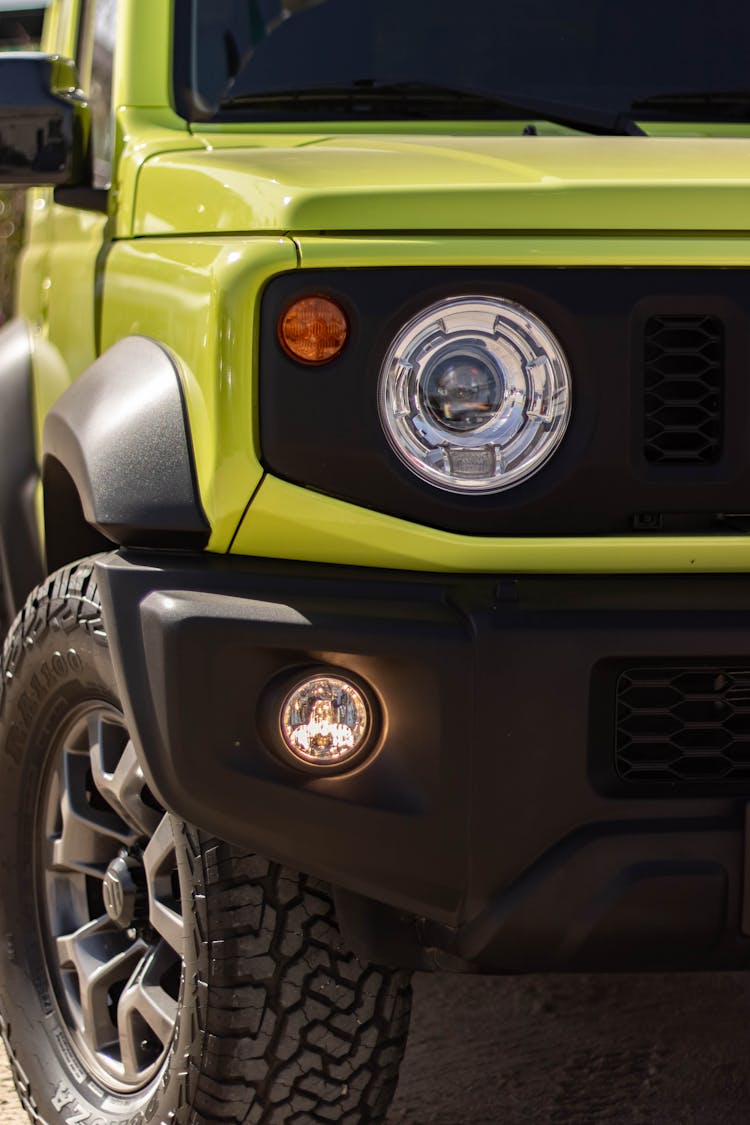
[616,663,750,782]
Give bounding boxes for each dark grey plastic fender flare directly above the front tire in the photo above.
[42,336,210,569]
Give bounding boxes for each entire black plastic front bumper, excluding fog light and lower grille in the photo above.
[98,551,750,971]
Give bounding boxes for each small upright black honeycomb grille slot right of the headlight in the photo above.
[644,316,724,465]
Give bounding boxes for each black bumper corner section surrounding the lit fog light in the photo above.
[98,549,472,920]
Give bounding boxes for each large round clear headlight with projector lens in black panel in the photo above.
[379,297,571,493]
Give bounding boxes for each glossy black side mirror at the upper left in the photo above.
[0,52,91,188]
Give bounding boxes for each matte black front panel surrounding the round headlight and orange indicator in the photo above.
[260,267,750,537]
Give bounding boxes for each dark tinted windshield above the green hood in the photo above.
[175,0,750,127]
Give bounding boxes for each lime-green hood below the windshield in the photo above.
[134,135,750,235]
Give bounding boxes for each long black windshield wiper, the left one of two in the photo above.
[219,81,644,136]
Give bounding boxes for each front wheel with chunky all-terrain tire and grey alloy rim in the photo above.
[0,561,410,1125]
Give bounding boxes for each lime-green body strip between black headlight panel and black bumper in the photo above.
[232,477,750,574]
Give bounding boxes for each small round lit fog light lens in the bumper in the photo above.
[281,675,372,766]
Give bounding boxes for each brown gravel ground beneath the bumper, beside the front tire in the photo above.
[0,973,750,1125]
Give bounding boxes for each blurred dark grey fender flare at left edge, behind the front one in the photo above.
[0,320,44,621]
